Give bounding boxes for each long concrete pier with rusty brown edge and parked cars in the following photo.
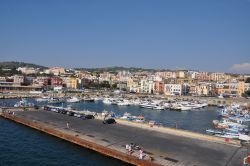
[1,110,245,166]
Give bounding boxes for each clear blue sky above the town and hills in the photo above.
[0,0,250,73]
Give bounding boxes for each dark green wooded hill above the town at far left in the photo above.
[0,61,47,69]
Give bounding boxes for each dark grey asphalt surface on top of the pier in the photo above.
[11,111,246,166]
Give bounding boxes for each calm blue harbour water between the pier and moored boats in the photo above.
[0,99,219,133]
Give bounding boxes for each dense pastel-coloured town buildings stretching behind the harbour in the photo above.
[0,63,250,98]
